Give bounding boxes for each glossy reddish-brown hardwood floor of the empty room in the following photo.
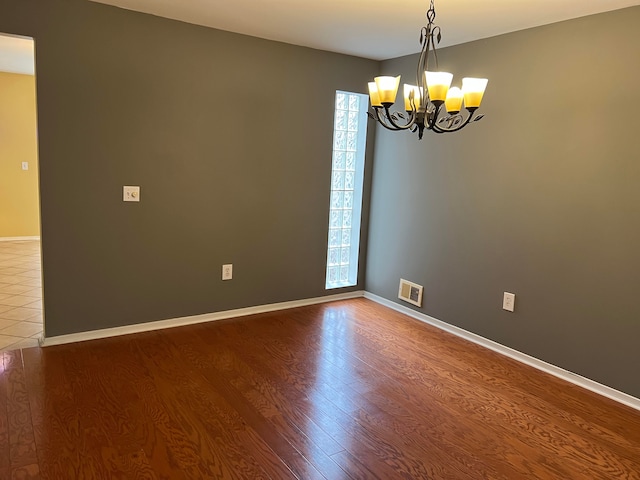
[0,299,640,480]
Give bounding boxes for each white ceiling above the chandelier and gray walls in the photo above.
[87,0,640,60]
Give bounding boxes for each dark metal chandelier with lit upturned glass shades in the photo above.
[367,0,488,139]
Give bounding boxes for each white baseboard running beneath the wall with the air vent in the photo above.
[364,292,640,410]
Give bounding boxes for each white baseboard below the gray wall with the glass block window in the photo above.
[39,290,364,347]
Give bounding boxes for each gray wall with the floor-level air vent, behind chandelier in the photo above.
[366,7,640,397]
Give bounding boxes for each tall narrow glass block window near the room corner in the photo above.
[325,91,369,289]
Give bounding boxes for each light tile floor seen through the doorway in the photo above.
[0,240,42,351]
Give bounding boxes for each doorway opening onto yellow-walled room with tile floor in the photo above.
[0,34,43,351]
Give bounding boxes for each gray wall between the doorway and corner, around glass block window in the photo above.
[0,0,379,337]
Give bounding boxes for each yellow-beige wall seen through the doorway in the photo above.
[0,72,40,238]
